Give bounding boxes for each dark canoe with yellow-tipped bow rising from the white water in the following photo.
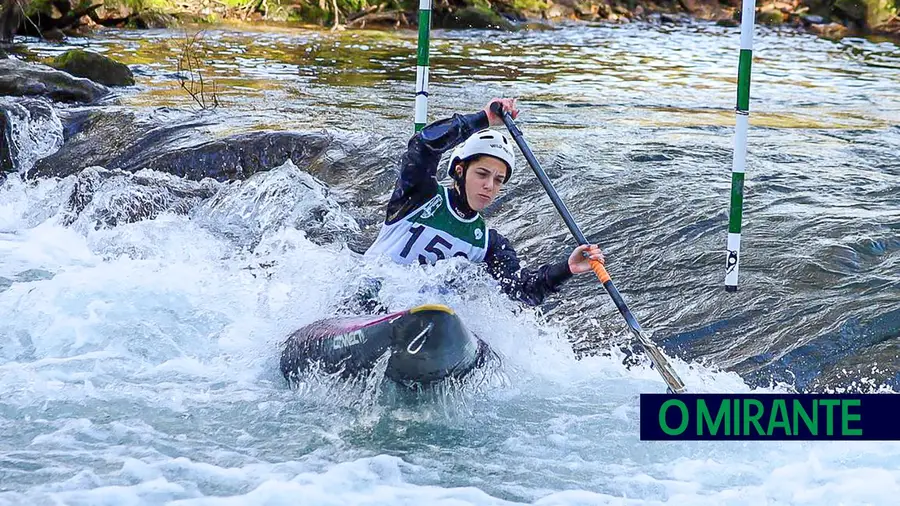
[281,304,494,388]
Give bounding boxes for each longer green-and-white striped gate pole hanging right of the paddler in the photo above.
[725,0,756,292]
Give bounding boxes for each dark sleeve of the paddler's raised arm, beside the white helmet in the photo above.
[385,111,489,224]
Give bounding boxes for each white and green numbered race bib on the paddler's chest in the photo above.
[366,186,488,264]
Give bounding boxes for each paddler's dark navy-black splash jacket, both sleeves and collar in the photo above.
[376,111,572,306]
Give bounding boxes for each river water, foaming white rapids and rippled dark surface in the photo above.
[0,19,900,505]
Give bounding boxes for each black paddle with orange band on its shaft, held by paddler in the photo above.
[491,102,685,394]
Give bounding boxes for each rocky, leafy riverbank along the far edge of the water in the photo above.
[0,0,900,41]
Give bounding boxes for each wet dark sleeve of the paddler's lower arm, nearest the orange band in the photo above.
[484,229,572,306]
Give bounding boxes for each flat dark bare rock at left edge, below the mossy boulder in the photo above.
[0,58,109,102]
